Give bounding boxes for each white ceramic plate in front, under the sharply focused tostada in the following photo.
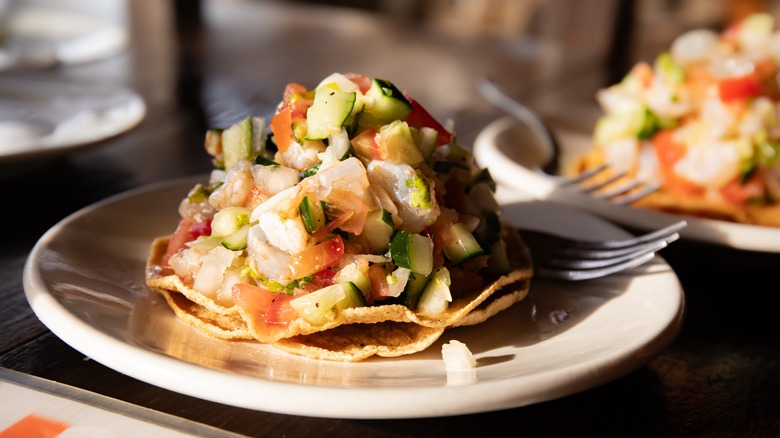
[24,176,684,418]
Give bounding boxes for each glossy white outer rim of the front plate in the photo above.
[23,176,686,419]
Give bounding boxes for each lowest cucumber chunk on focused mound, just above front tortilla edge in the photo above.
[290,282,366,325]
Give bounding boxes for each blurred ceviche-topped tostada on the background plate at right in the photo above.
[568,14,780,226]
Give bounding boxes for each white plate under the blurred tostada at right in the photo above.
[474,117,780,253]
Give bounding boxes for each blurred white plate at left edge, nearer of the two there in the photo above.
[0,76,146,166]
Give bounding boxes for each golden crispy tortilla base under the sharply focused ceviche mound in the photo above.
[146,221,532,361]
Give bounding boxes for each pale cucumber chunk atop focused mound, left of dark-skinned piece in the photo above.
[306,86,357,140]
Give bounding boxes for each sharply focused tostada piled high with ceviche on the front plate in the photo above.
[147,73,532,360]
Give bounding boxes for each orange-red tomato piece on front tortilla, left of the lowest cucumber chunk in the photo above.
[233,283,298,330]
